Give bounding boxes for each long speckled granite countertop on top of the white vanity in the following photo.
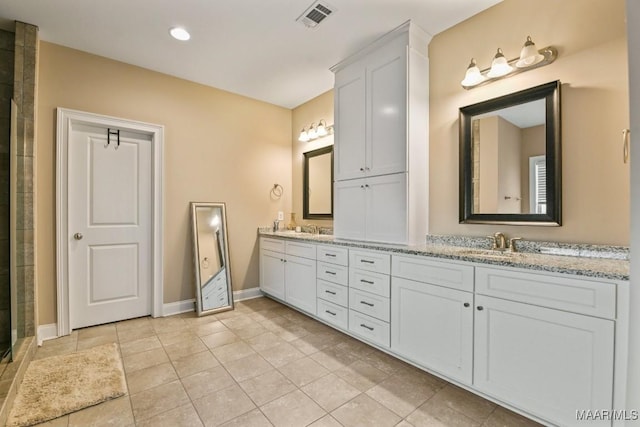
[258,228,629,280]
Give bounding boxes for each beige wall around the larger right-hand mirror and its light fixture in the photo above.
[429,0,629,245]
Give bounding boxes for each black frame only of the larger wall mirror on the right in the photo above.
[459,80,562,226]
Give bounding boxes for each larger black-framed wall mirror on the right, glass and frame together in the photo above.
[459,81,562,226]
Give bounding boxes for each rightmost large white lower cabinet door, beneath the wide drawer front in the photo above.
[473,295,614,426]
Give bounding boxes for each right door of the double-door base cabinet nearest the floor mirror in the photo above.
[284,255,316,315]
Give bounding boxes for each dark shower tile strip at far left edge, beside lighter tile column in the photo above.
[0,30,15,352]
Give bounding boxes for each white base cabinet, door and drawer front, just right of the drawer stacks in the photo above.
[391,256,473,385]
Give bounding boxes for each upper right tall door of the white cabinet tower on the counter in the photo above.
[365,37,404,176]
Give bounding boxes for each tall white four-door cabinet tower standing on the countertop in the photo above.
[331,22,430,247]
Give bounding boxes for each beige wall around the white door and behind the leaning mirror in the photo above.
[36,42,291,324]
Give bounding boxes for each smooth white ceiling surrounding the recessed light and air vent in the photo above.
[0,0,501,108]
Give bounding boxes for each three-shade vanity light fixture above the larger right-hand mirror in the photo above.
[460,36,558,89]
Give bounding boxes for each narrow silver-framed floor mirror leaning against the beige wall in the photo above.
[191,202,233,316]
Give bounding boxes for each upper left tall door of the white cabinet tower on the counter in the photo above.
[333,62,366,181]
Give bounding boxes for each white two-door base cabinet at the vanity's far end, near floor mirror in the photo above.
[260,237,316,315]
